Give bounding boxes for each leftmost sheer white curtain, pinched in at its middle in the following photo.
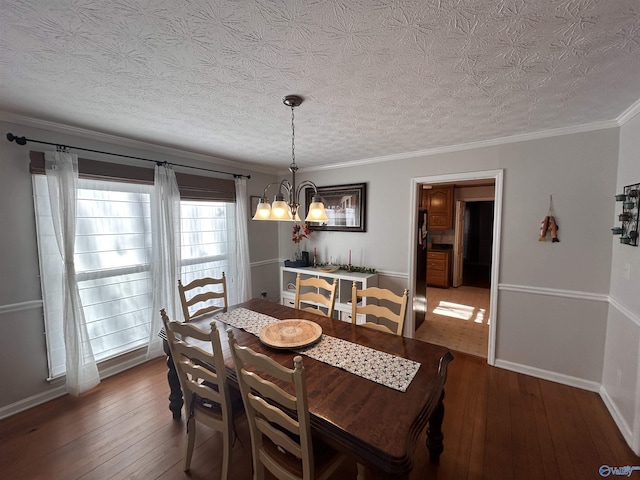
[45,152,100,395]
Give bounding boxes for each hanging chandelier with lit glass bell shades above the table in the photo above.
[253,95,329,223]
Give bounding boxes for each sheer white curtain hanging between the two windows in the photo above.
[147,164,181,358]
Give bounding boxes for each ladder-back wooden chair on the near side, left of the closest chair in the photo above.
[160,309,234,480]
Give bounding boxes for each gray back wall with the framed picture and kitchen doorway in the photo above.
[280,128,618,390]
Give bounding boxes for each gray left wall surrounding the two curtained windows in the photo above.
[0,121,278,418]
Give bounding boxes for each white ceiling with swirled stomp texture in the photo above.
[0,0,640,167]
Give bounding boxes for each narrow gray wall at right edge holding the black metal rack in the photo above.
[602,115,640,455]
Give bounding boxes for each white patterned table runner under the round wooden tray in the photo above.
[214,308,420,392]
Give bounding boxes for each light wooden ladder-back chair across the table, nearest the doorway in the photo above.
[351,282,409,335]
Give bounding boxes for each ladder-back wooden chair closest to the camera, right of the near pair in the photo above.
[227,329,345,480]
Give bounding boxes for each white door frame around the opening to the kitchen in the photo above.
[405,169,504,365]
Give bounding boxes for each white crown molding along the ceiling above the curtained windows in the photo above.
[0,111,275,175]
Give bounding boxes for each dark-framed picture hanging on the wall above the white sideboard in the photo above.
[305,183,367,232]
